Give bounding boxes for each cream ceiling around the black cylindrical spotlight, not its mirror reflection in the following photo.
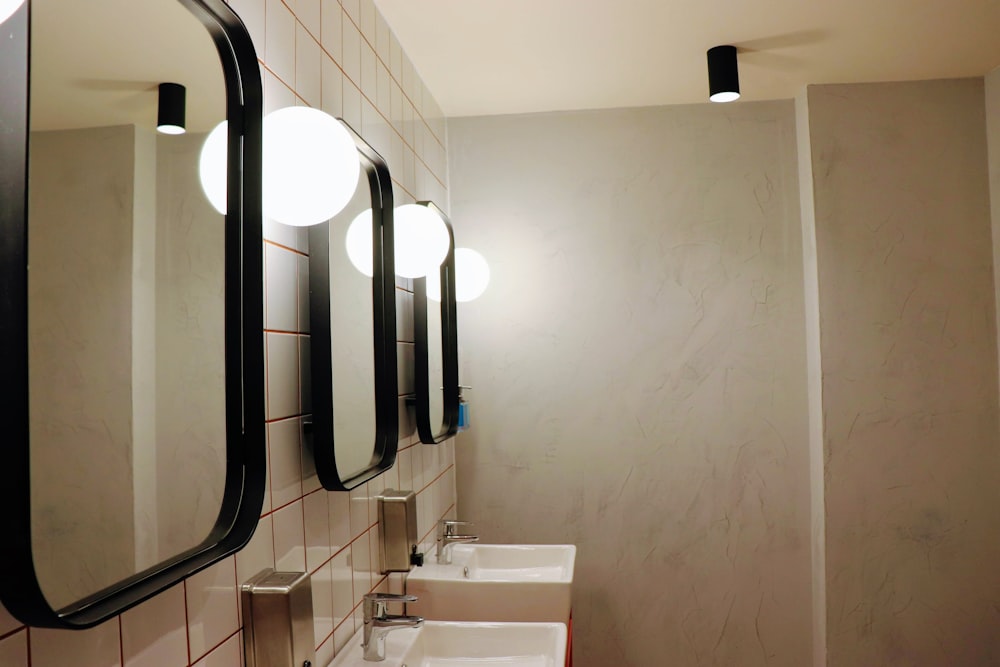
[375,0,1000,116]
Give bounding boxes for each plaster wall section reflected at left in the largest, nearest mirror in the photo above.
[28,126,135,607]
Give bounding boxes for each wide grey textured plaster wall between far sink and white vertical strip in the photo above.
[449,101,811,667]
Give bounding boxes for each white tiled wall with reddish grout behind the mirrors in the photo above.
[0,0,455,667]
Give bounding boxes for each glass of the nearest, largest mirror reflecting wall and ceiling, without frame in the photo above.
[28,0,226,608]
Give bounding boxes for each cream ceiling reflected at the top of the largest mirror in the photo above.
[31,0,226,131]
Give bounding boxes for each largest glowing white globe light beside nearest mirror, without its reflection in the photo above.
[263,107,361,227]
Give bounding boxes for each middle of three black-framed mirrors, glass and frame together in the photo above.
[308,121,399,491]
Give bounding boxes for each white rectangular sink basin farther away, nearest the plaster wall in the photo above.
[406,544,576,624]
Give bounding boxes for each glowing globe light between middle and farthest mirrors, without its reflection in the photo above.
[392,204,450,278]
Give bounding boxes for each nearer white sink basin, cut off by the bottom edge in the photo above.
[330,621,566,667]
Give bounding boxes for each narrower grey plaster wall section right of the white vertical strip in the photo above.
[808,79,1000,666]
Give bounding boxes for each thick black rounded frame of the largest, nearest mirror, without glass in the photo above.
[0,0,267,629]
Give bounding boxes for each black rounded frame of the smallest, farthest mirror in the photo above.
[413,201,460,445]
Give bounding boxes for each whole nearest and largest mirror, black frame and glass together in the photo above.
[0,0,266,629]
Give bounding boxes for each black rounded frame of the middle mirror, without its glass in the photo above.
[307,119,399,491]
